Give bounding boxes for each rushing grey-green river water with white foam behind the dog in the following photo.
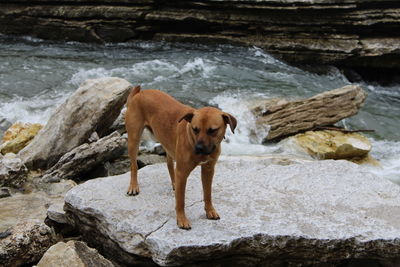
[0,36,400,186]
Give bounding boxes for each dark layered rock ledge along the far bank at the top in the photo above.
[0,0,400,81]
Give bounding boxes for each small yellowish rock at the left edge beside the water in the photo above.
[0,122,43,155]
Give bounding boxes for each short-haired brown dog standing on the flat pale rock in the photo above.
[125,86,236,229]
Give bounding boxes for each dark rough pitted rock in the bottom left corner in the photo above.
[0,222,57,266]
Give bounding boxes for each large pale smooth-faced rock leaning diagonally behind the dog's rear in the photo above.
[19,77,131,169]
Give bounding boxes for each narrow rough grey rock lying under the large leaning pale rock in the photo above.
[43,132,127,182]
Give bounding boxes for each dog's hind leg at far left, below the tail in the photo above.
[125,107,144,196]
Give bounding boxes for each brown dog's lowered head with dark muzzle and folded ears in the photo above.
[179,107,237,155]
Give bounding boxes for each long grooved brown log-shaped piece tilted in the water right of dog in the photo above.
[253,85,367,143]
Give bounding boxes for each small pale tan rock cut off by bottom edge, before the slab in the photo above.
[37,241,114,267]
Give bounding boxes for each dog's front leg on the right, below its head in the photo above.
[201,161,219,220]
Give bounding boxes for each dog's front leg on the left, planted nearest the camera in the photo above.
[175,162,194,230]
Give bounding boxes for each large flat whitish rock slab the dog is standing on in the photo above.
[64,158,400,266]
